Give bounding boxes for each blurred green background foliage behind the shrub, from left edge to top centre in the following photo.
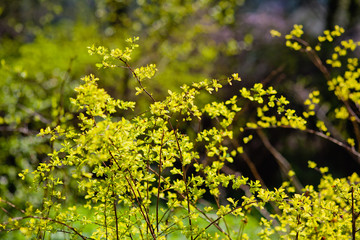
[0,0,253,232]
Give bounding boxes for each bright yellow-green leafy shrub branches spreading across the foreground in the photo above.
[0,25,360,239]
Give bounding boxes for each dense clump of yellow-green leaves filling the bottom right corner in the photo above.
[258,166,360,239]
